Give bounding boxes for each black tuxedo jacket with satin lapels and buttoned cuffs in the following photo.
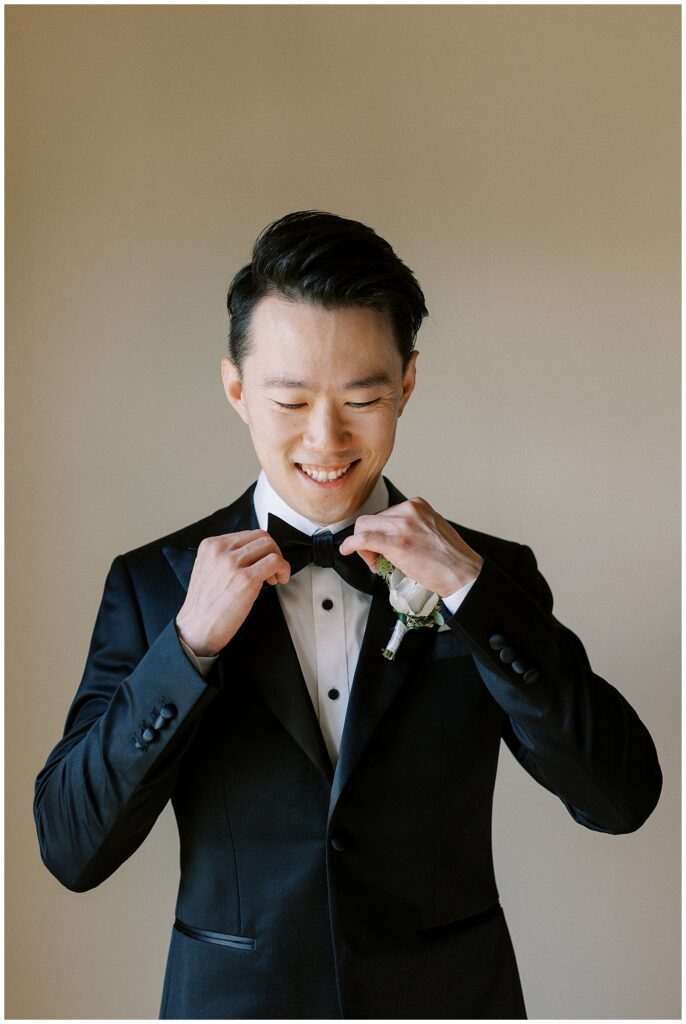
[34,481,661,1019]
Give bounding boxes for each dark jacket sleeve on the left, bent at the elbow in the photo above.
[34,555,217,892]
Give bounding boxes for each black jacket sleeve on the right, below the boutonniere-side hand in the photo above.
[446,546,662,834]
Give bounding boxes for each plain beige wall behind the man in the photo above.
[6,5,680,1018]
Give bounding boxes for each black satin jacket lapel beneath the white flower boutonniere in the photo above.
[329,578,431,819]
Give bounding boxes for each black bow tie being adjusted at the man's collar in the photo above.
[267,512,377,594]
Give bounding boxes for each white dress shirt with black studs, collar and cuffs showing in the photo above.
[181,470,472,765]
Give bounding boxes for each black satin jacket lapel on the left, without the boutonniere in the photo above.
[163,487,334,784]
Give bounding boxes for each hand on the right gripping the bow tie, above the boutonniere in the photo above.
[340,498,483,597]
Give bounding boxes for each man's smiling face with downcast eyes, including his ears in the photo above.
[221,295,417,524]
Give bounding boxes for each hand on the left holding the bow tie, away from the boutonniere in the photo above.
[176,529,291,657]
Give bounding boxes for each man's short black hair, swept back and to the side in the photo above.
[226,210,428,373]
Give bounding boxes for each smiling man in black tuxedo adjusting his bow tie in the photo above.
[35,211,661,1019]
